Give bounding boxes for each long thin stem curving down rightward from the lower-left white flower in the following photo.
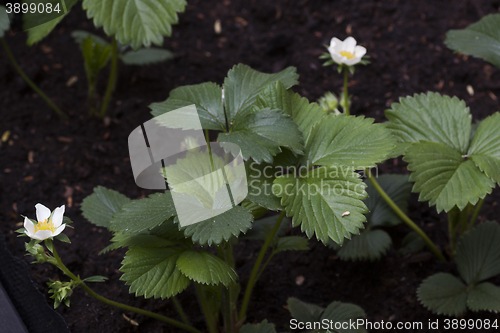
[49,241,201,333]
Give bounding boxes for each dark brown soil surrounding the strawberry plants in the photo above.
[0,0,500,333]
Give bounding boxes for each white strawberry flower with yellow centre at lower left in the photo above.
[24,203,66,240]
